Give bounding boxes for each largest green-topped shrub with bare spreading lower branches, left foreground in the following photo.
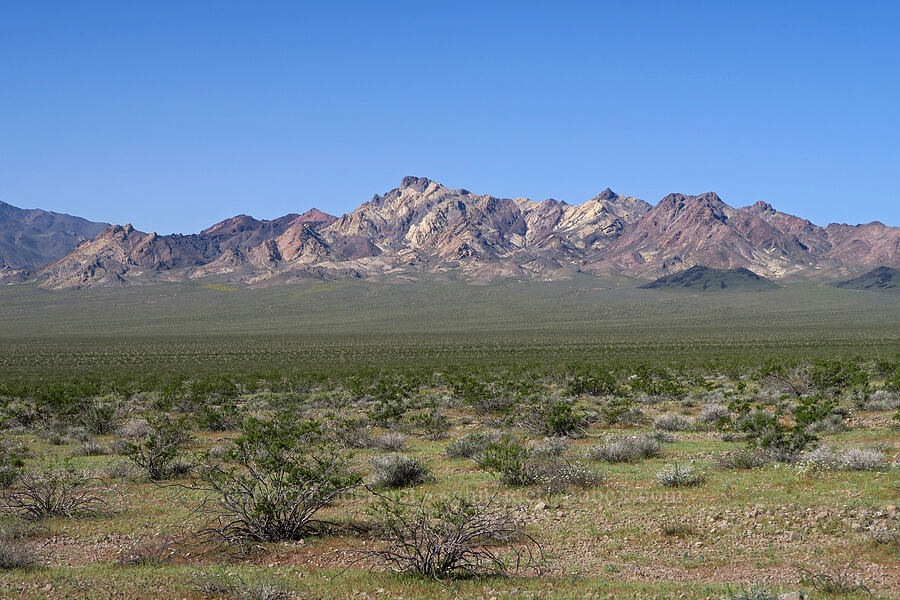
[192,415,359,549]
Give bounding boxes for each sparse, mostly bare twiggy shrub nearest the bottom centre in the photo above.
[362,494,543,579]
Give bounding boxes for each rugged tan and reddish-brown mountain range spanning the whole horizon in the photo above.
[0,177,900,288]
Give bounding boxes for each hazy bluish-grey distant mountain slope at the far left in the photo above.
[0,202,107,272]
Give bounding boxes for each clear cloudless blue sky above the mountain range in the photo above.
[0,0,900,233]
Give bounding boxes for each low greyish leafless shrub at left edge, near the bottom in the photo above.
[3,467,109,520]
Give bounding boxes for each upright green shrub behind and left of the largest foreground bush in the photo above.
[123,416,191,481]
